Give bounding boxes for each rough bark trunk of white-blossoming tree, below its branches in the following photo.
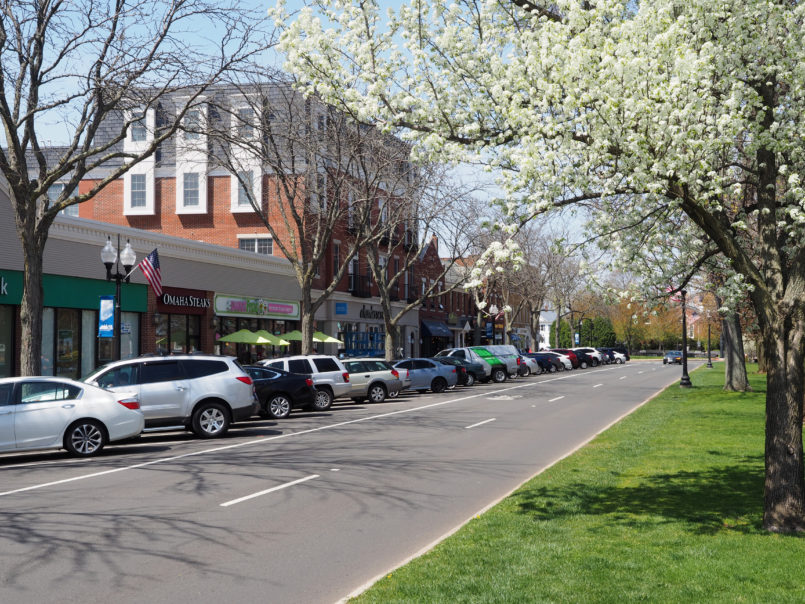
[763,320,805,532]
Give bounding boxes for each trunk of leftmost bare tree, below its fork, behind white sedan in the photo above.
[20,237,45,376]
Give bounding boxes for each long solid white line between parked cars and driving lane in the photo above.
[0,369,636,497]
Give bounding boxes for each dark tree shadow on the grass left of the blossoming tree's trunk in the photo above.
[519,456,763,534]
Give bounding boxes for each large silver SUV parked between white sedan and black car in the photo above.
[83,354,259,438]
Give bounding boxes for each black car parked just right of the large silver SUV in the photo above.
[243,365,316,419]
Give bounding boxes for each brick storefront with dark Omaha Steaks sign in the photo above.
[153,287,212,354]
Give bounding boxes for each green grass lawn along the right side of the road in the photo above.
[355,363,805,603]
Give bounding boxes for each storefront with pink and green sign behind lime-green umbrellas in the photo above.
[212,294,301,363]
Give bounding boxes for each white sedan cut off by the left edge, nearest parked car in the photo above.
[0,377,145,457]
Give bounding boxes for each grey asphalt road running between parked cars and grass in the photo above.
[0,362,692,604]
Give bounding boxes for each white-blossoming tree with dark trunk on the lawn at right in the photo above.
[275,0,805,531]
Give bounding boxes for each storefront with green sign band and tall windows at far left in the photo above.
[0,271,147,379]
